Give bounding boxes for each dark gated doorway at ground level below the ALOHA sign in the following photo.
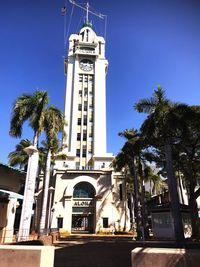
[72,214,94,233]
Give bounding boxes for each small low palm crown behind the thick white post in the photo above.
[8,139,32,171]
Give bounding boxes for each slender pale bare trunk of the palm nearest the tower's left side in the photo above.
[39,149,51,235]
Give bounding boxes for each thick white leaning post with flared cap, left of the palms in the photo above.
[17,145,39,241]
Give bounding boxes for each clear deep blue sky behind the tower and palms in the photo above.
[0,0,200,163]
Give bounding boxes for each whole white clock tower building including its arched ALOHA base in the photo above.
[51,17,130,233]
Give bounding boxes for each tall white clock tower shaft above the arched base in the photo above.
[64,16,113,169]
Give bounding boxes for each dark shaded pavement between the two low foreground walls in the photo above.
[54,236,178,267]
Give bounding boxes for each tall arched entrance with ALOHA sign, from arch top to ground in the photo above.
[71,182,95,233]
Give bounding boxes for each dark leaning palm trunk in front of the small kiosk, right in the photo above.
[165,140,184,247]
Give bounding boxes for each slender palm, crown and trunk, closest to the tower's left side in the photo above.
[40,106,65,234]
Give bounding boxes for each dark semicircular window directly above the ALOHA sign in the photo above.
[73,182,95,198]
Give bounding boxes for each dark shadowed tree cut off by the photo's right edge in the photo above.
[174,106,200,238]
